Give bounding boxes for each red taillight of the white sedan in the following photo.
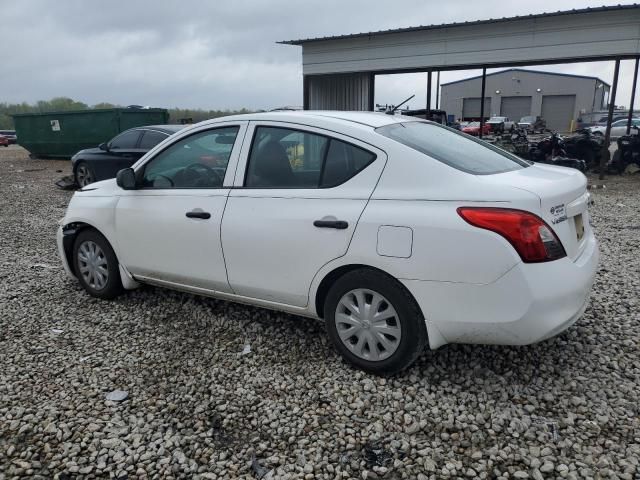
[458,207,567,263]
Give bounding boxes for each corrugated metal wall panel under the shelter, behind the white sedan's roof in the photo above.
[307,72,374,110]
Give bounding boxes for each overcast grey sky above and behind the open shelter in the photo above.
[0,0,633,109]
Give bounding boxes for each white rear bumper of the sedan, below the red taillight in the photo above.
[402,234,599,348]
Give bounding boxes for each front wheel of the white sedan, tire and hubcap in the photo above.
[73,230,122,299]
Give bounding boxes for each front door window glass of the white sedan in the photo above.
[142,127,239,189]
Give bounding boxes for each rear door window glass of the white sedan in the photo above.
[244,127,376,188]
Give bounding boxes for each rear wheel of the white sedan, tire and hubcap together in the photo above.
[324,268,427,375]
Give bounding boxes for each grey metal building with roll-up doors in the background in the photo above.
[440,68,609,131]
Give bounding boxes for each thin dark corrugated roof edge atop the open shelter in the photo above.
[276,3,640,45]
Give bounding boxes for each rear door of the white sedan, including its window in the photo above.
[222,122,386,307]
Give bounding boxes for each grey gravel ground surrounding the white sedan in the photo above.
[0,146,640,480]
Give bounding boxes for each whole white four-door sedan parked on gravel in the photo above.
[58,111,598,373]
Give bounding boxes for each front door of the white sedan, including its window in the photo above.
[115,122,247,293]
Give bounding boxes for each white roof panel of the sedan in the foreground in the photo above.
[195,110,410,128]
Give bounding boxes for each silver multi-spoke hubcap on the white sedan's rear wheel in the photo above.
[335,288,402,362]
